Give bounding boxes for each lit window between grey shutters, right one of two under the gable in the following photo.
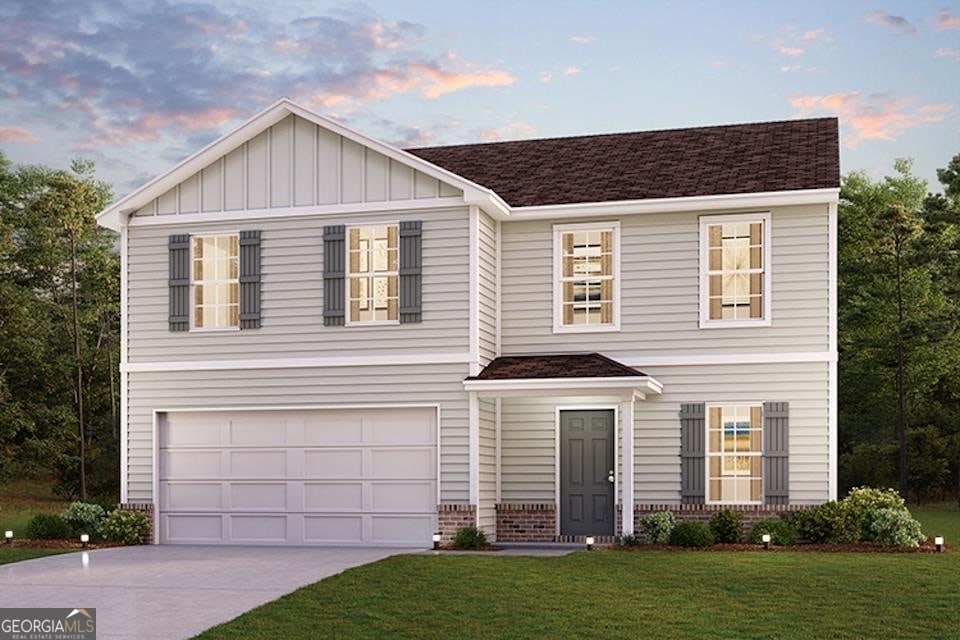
[347,225,399,323]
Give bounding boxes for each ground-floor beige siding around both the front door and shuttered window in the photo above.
[500,362,829,504]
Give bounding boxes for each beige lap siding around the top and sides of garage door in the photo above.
[127,364,469,502]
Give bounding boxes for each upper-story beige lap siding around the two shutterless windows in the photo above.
[501,205,829,360]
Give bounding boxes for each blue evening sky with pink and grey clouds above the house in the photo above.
[0,0,960,200]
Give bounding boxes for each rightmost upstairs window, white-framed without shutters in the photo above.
[700,214,770,326]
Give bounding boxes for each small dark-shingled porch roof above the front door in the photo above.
[468,353,646,380]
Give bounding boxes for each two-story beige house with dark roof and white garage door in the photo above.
[99,99,839,546]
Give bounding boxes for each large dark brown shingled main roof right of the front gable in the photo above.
[407,118,840,207]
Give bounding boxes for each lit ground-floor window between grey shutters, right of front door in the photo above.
[707,404,763,503]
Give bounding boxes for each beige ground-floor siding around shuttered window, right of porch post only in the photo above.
[634,363,829,504]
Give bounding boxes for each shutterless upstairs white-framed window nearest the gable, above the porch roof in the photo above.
[554,223,620,332]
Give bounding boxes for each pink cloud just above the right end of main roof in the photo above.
[790,91,953,147]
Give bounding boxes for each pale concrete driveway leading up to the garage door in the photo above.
[0,545,411,640]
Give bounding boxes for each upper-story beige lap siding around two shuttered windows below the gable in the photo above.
[127,207,470,363]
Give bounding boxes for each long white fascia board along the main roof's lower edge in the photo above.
[510,188,840,220]
